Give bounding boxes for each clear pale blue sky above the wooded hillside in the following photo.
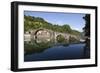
[24,11,85,32]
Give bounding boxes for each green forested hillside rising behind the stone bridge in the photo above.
[24,15,81,35]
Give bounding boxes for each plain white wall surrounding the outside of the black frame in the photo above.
[0,0,100,73]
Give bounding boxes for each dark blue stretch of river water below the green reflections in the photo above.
[24,43,90,62]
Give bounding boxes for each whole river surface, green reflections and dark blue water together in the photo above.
[24,38,90,62]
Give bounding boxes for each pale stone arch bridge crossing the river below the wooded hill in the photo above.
[24,28,78,41]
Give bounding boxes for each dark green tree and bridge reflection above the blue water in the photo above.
[24,37,79,55]
